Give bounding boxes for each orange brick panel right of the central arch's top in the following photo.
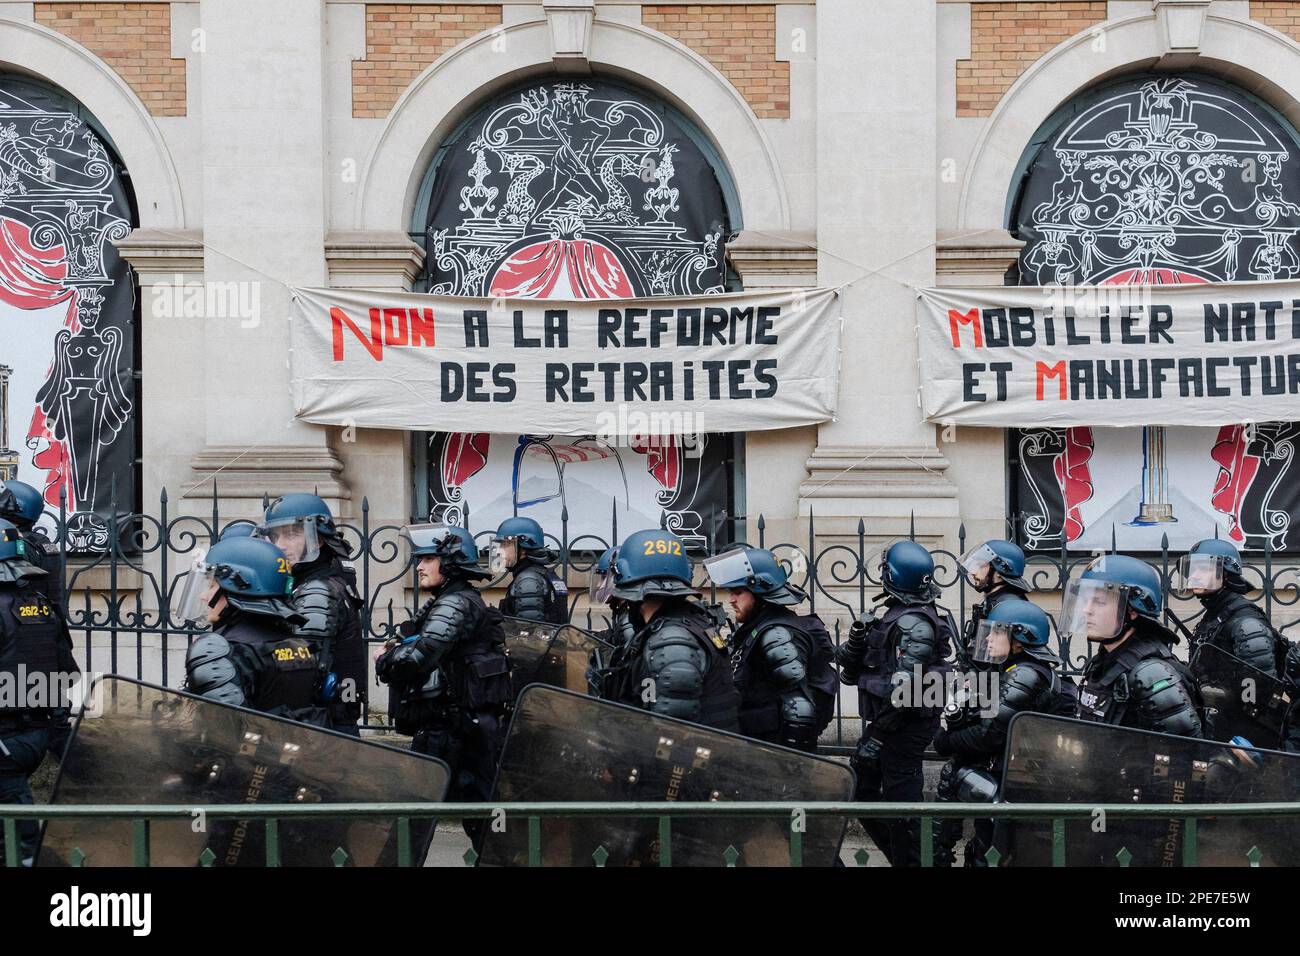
[641,4,790,118]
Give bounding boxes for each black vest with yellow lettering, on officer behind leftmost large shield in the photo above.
[216,613,325,724]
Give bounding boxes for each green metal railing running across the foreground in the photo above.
[0,803,1300,866]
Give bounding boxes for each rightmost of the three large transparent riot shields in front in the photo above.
[991,713,1300,866]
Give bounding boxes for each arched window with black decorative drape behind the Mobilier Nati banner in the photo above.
[1009,74,1300,550]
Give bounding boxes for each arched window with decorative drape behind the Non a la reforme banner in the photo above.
[416,78,740,544]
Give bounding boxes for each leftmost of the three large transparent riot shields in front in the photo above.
[38,676,449,866]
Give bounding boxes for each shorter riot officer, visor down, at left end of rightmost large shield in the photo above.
[935,598,1061,866]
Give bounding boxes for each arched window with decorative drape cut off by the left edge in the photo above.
[0,74,139,550]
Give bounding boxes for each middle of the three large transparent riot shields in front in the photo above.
[481,685,854,866]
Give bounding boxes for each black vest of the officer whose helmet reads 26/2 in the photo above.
[607,601,740,731]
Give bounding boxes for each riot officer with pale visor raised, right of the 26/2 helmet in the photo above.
[705,548,839,753]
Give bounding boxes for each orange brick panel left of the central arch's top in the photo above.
[352,4,501,117]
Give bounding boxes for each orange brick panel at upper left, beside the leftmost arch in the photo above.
[34,3,185,116]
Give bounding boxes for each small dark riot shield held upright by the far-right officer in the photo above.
[1191,643,1291,748]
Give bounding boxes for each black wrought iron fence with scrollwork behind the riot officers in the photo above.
[38,483,1300,752]
